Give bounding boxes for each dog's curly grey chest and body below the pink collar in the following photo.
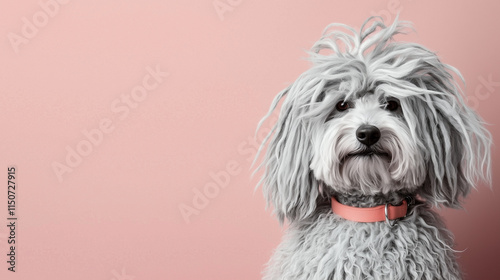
[267,214,460,280]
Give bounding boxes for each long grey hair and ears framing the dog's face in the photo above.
[254,17,491,223]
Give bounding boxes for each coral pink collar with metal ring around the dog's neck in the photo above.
[332,197,408,226]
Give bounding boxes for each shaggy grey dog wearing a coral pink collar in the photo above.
[257,17,491,280]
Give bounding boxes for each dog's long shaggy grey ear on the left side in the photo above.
[254,87,319,223]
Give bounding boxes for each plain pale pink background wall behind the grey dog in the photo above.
[0,0,500,280]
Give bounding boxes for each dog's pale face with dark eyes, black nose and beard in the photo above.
[310,88,426,195]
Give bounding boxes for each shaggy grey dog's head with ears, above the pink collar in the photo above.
[261,18,491,221]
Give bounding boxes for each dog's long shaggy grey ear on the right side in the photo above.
[411,68,491,208]
